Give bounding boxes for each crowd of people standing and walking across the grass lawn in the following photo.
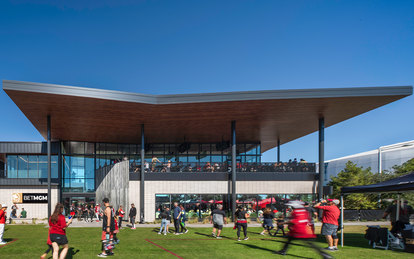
[0,198,414,259]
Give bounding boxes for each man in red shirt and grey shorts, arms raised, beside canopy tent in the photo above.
[314,200,341,251]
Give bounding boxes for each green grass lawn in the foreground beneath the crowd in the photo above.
[0,225,414,259]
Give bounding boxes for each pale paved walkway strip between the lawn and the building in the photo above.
[71,219,390,228]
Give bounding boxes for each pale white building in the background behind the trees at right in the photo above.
[324,140,414,184]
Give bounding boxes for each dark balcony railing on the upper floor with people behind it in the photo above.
[130,162,316,173]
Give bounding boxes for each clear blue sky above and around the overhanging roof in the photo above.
[0,0,414,161]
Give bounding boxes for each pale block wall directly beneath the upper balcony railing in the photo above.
[129,181,314,222]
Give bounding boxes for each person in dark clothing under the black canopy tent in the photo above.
[382,200,414,234]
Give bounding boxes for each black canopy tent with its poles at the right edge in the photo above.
[341,172,414,246]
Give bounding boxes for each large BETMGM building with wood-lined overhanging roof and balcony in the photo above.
[0,81,412,222]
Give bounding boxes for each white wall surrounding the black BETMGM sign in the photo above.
[0,186,58,219]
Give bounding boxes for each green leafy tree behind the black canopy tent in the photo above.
[328,164,377,209]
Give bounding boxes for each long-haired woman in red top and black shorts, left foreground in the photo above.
[49,203,73,259]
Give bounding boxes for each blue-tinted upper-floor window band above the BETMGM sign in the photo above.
[5,155,58,178]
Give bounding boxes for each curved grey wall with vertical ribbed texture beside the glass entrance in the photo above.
[96,161,129,215]
